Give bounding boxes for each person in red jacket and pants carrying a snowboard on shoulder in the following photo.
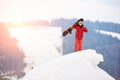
[63,18,88,52]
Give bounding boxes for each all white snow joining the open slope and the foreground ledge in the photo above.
[9,27,114,80]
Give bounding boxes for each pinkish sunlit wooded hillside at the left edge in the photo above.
[0,23,26,80]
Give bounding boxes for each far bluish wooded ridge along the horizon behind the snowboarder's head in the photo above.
[50,18,120,33]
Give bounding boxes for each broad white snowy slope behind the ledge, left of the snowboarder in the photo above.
[9,26,62,72]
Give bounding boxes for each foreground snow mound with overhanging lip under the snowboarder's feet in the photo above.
[22,50,114,80]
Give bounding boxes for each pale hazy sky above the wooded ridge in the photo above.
[0,0,120,23]
